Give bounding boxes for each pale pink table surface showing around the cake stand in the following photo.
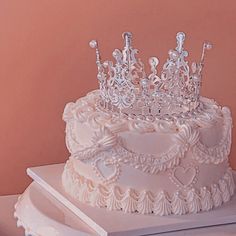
[0,195,236,236]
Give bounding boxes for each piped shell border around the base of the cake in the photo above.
[62,160,235,216]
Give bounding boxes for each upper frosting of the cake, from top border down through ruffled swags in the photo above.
[64,90,232,174]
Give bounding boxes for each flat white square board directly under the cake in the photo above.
[27,164,236,236]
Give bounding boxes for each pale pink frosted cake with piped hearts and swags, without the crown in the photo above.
[62,91,235,215]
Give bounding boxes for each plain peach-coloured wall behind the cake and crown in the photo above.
[0,0,236,195]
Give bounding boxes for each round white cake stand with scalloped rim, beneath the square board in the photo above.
[14,181,98,236]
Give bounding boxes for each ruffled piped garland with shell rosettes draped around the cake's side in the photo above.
[66,97,232,175]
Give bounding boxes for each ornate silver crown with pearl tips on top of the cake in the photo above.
[89,32,212,119]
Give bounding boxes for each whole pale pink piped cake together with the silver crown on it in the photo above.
[62,33,235,216]
